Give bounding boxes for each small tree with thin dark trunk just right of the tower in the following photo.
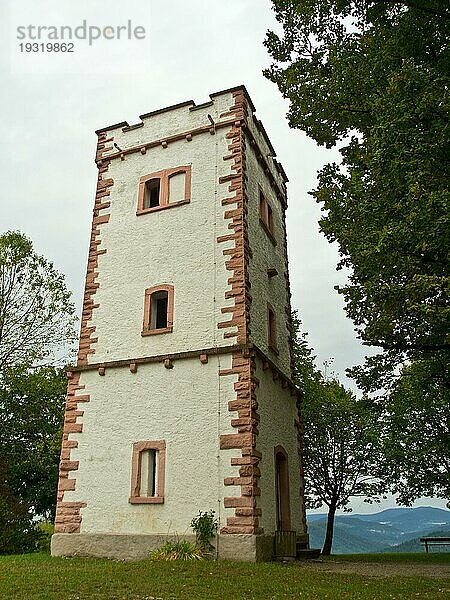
[294,317,383,555]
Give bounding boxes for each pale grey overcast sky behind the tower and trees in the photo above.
[0,0,442,511]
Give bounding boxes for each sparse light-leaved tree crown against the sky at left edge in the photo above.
[0,231,75,375]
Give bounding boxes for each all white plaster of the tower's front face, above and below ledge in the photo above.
[64,93,246,534]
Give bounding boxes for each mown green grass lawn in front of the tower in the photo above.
[0,554,450,600]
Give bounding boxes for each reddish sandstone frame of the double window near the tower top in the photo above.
[136,165,192,215]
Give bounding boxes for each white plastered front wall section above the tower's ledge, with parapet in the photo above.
[87,94,237,363]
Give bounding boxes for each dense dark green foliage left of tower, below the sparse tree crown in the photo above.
[0,367,67,518]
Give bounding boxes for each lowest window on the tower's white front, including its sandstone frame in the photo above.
[128,440,166,504]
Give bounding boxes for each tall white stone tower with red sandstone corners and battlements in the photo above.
[52,86,306,560]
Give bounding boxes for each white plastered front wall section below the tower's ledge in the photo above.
[64,356,243,534]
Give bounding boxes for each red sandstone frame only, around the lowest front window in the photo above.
[128,440,166,504]
